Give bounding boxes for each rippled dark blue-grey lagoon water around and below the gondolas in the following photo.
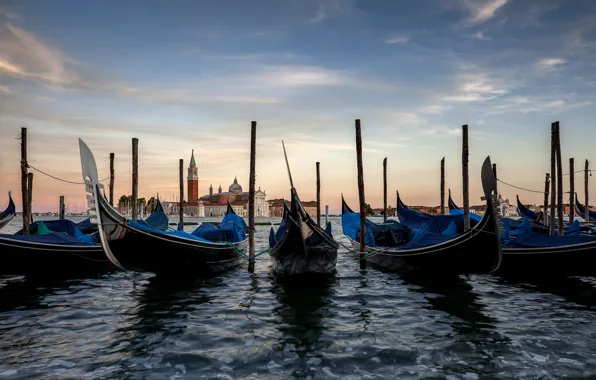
[0,218,596,380]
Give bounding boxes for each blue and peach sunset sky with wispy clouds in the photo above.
[0,0,596,212]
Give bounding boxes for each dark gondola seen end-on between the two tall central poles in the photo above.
[269,189,339,277]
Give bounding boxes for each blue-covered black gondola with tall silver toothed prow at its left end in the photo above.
[79,139,248,277]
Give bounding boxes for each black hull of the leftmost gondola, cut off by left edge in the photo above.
[0,237,110,277]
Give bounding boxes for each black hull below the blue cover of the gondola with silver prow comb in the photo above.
[98,196,247,276]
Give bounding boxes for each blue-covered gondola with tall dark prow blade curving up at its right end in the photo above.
[342,157,502,275]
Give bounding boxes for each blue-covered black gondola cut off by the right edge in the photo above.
[451,190,596,277]
